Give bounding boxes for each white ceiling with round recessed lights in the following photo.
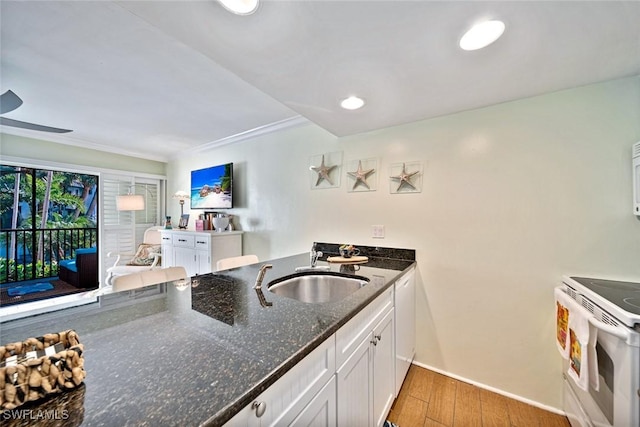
[0,0,640,161]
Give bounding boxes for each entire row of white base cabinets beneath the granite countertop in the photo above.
[225,269,415,427]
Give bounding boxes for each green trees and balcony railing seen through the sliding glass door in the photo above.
[0,165,98,283]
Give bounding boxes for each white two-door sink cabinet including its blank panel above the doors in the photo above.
[336,287,395,426]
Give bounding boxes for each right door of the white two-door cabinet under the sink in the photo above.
[372,309,395,427]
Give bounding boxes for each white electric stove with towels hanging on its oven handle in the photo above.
[561,276,640,427]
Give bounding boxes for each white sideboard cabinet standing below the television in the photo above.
[161,230,242,276]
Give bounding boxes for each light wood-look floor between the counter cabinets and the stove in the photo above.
[388,365,570,427]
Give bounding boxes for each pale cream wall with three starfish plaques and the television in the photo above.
[167,76,640,408]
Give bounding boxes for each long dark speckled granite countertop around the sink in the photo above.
[1,244,415,426]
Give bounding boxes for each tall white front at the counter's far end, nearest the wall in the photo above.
[395,268,416,397]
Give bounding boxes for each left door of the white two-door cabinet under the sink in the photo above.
[337,333,373,427]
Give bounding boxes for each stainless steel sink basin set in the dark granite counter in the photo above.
[267,271,369,303]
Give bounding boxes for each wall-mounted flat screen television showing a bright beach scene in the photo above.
[191,163,233,209]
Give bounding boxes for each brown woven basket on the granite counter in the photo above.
[0,330,87,410]
